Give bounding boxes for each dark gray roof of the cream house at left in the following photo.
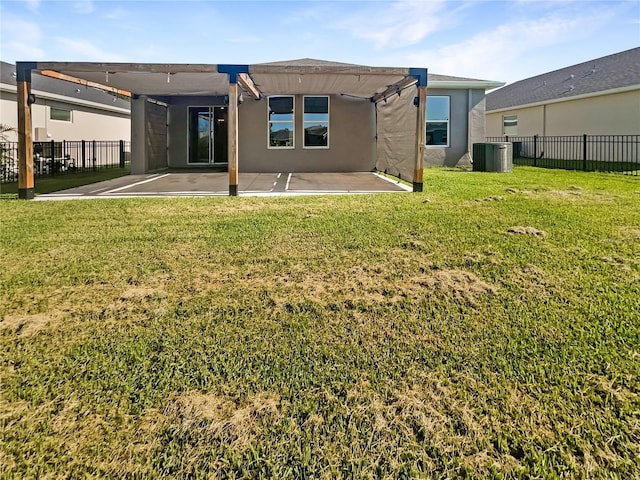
[0,62,131,110]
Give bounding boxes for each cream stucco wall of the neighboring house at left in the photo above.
[0,91,131,141]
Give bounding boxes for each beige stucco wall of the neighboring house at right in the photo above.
[486,90,640,137]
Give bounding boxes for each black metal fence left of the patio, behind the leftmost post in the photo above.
[0,140,131,183]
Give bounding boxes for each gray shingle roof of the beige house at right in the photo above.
[486,47,640,111]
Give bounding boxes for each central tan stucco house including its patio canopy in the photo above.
[8,59,503,197]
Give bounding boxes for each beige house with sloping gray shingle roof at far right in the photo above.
[486,48,640,137]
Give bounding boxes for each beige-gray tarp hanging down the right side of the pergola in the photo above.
[376,86,418,182]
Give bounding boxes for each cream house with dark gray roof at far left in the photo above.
[0,62,131,142]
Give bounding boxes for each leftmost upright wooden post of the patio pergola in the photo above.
[17,79,35,200]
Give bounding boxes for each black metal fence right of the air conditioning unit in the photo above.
[487,135,640,175]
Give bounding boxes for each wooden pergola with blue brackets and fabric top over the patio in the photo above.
[16,59,427,199]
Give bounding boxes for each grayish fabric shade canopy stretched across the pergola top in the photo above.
[30,59,420,98]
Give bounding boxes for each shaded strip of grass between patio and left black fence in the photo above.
[0,167,130,195]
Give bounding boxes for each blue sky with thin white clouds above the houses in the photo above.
[0,0,640,83]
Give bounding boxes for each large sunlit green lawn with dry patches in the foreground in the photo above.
[0,167,640,479]
